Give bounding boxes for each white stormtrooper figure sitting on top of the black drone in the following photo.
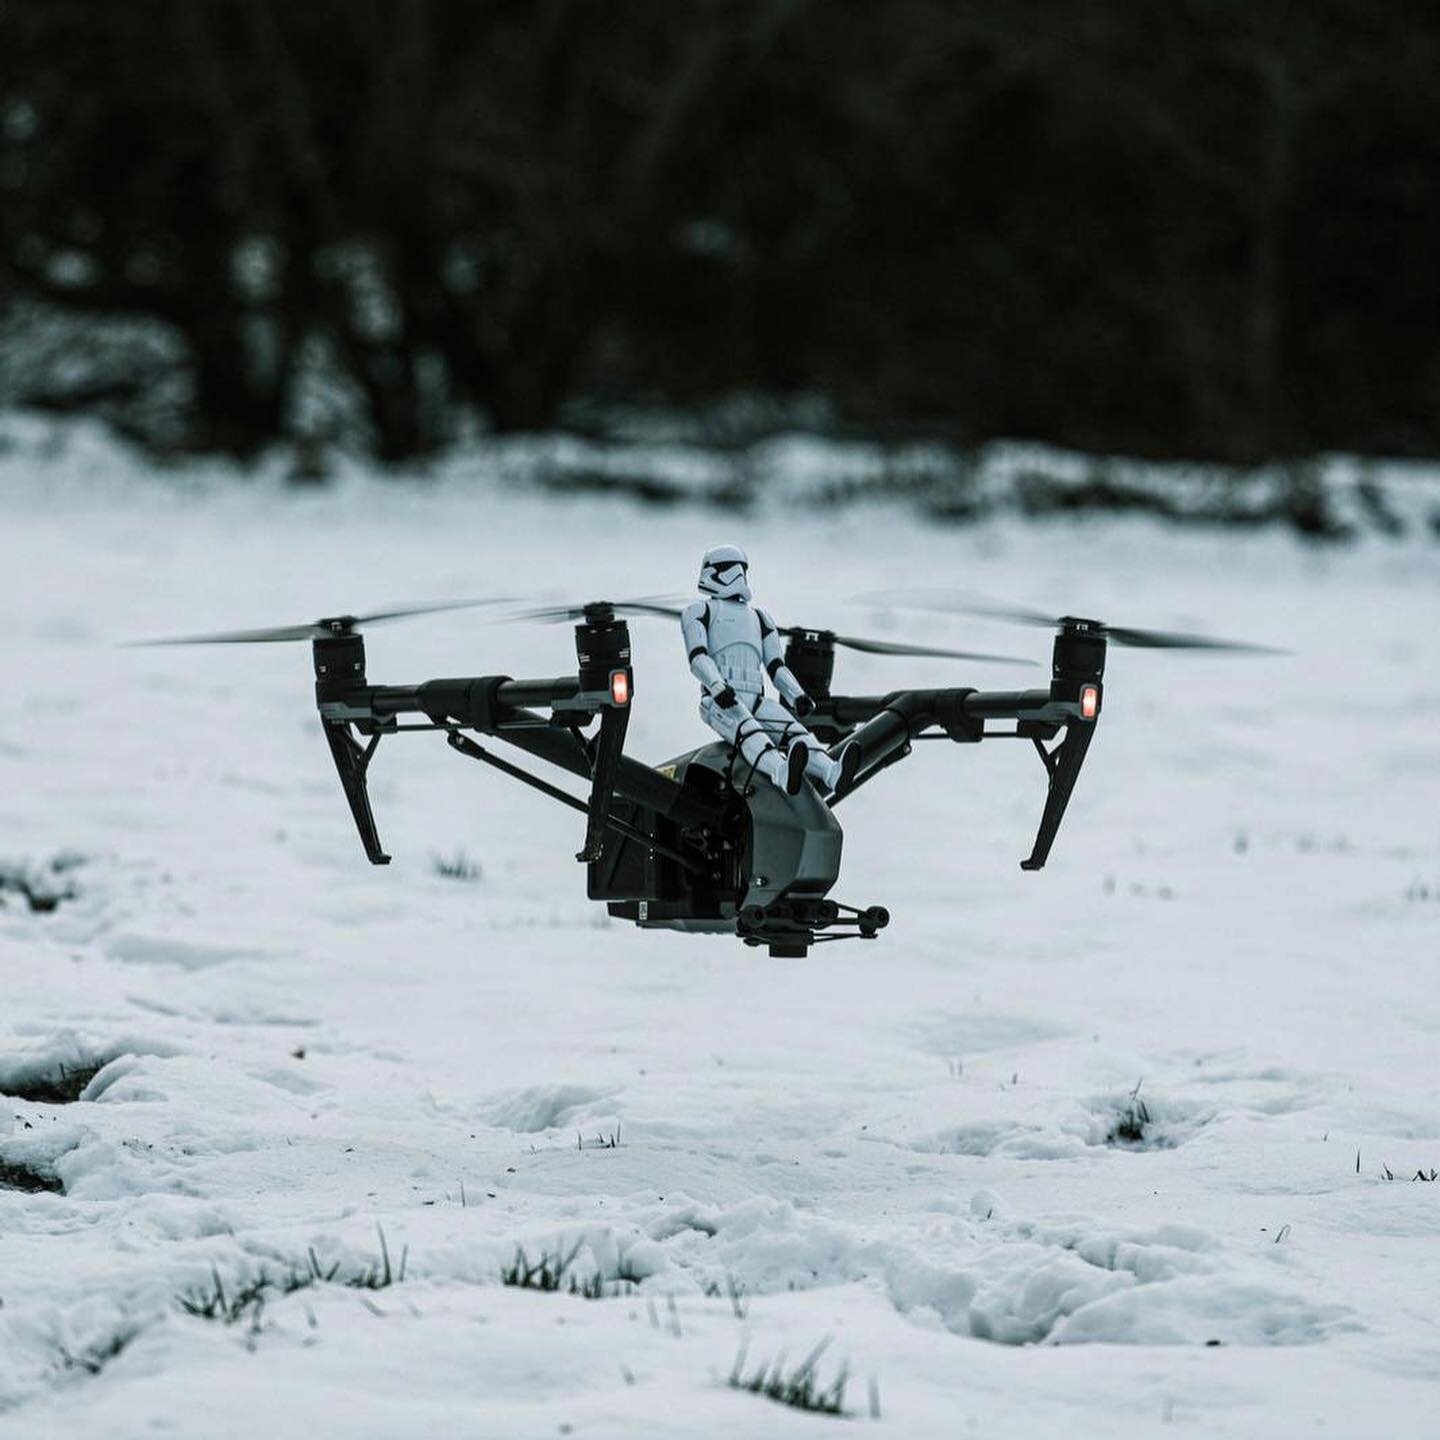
[680,544,860,795]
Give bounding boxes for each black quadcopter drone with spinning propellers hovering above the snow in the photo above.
[138,590,1277,956]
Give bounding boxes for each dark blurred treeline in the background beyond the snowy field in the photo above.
[0,0,1440,461]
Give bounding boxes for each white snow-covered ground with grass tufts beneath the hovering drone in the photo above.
[8,411,1440,1440]
